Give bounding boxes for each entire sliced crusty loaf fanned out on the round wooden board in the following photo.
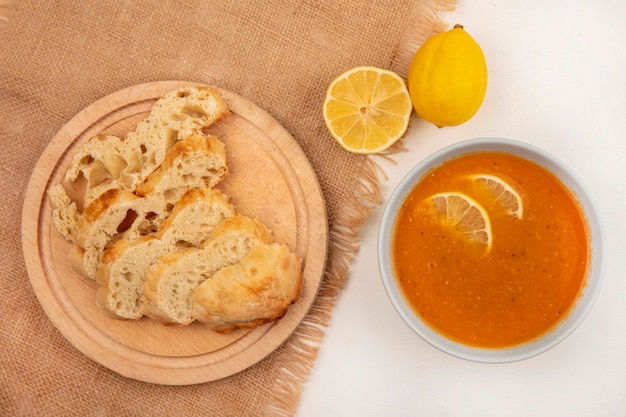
[48,87,302,332]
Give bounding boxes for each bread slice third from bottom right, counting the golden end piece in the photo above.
[97,189,235,319]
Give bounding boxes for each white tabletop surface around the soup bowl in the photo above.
[297,0,626,417]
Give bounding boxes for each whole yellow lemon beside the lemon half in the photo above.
[407,24,487,127]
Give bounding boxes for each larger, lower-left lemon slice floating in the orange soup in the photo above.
[428,192,493,251]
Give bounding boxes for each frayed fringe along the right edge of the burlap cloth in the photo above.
[263,0,456,416]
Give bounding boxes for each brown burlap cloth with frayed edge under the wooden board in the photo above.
[0,0,453,416]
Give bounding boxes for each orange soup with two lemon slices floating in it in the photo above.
[390,151,591,348]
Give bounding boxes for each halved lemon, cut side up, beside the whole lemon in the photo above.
[323,66,413,153]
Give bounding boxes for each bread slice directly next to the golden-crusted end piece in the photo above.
[142,215,272,325]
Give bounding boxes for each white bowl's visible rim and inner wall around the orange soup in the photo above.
[378,138,604,363]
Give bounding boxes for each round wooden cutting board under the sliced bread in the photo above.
[22,81,328,385]
